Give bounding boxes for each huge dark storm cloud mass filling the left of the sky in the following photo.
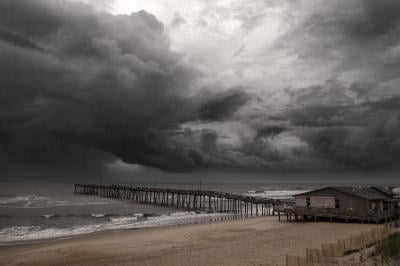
[0,0,250,174]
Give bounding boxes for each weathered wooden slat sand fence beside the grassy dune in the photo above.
[286,227,394,266]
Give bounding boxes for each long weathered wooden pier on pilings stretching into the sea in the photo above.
[74,184,282,217]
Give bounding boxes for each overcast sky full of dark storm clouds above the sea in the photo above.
[0,0,400,181]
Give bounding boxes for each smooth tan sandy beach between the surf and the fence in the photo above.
[0,217,376,265]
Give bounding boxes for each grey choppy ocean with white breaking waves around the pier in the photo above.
[0,183,396,245]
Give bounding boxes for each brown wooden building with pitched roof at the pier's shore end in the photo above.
[284,187,400,223]
